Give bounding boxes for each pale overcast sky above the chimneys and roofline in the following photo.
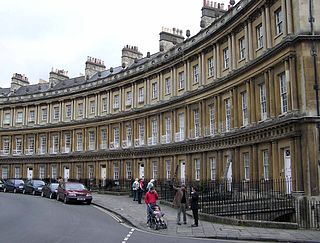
[0,0,238,88]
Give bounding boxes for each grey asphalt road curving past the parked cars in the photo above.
[0,192,260,243]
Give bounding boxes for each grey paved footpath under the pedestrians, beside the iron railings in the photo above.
[92,193,320,243]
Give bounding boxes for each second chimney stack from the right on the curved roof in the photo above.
[159,27,184,52]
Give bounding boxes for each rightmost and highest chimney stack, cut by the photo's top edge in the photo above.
[200,0,227,29]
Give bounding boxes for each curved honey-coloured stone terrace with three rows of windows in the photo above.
[0,0,320,196]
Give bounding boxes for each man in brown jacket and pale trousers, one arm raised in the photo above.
[173,184,188,225]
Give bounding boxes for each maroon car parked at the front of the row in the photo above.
[57,182,92,205]
